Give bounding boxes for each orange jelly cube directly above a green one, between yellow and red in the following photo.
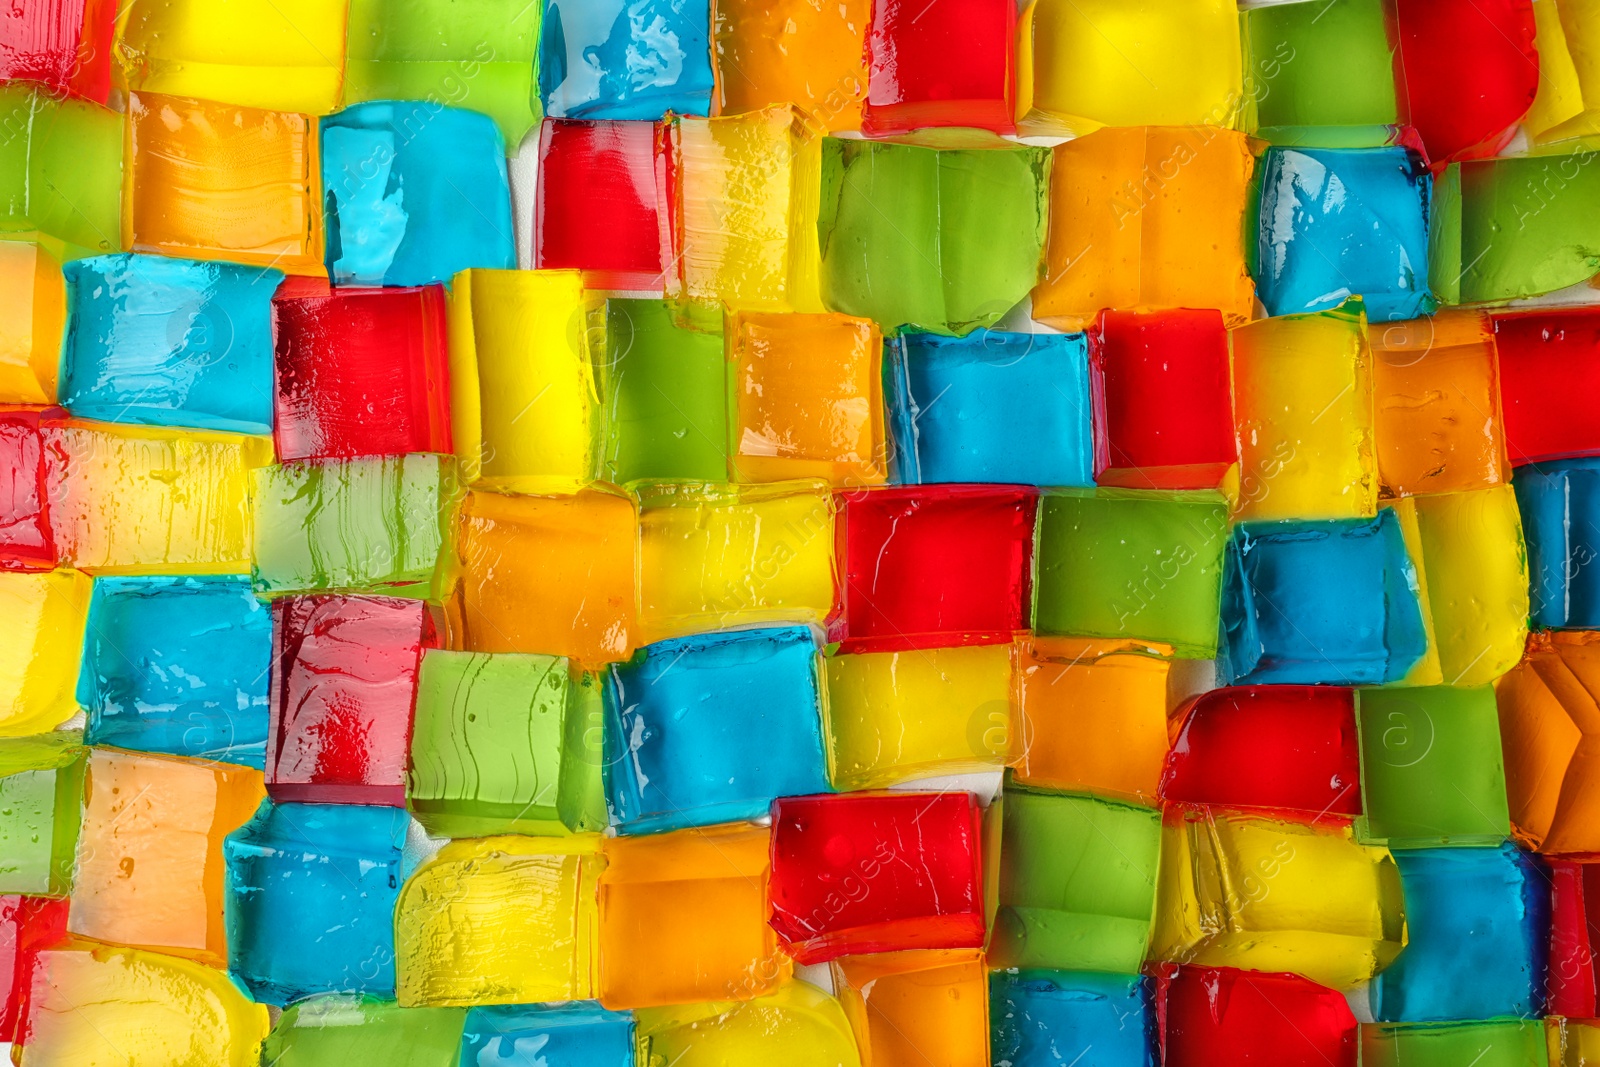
[1008,637,1173,803]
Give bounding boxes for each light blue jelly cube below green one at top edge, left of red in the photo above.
[320,101,517,285]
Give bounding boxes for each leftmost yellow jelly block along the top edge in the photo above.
[118,0,346,115]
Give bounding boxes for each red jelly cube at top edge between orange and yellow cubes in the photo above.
[861,0,1018,134]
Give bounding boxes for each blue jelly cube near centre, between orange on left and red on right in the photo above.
[883,330,1094,486]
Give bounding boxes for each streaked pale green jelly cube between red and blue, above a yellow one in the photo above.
[406,649,606,838]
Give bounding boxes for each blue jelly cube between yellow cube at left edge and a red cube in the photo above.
[77,576,272,769]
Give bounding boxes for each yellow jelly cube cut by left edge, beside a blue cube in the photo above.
[0,571,93,737]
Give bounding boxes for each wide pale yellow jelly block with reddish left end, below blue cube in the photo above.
[45,422,272,574]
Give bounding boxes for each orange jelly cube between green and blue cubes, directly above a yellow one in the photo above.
[726,312,888,486]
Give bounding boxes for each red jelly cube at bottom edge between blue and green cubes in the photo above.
[1155,966,1358,1067]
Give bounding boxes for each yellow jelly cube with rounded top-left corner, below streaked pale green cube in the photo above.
[395,835,602,1008]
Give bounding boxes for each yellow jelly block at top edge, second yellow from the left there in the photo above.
[1016,0,1245,134]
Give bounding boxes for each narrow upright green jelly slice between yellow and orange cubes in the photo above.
[603,301,728,485]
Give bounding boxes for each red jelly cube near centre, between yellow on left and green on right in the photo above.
[835,485,1038,653]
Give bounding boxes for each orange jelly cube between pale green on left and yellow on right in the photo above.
[456,490,638,665]
